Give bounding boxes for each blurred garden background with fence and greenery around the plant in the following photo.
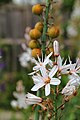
[0,0,80,120]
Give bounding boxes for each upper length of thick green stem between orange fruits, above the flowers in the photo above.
[42,0,50,58]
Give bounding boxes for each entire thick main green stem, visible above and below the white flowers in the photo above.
[34,0,50,120]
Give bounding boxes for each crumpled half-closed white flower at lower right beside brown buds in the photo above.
[61,85,76,96]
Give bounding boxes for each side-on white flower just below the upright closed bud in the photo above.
[57,55,70,74]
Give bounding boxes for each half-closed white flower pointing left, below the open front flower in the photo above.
[25,93,42,105]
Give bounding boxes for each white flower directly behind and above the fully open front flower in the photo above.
[29,52,53,75]
